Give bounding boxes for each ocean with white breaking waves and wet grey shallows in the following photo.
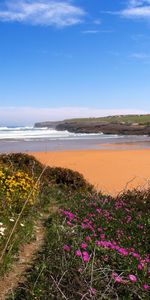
[0,126,150,153]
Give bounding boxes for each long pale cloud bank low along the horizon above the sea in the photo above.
[0,107,148,126]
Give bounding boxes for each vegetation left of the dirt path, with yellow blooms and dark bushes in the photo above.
[0,153,92,275]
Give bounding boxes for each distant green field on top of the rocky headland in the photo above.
[65,114,150,125]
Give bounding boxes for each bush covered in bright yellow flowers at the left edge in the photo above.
[0,168,39,212]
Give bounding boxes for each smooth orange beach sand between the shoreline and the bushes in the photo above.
[31,149,150,195]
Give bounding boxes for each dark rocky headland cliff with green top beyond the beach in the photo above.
[35,115,150,135]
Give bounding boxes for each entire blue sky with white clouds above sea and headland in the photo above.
[0,0,150,125]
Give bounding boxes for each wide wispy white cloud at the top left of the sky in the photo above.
[0,0,86,27]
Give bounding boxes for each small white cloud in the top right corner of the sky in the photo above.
[119,0,150,19]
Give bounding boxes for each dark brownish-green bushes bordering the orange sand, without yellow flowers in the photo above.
[0,153,93,190]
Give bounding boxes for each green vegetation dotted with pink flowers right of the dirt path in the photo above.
[11,191,150,300]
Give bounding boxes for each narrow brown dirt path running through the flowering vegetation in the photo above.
[0,207,58,300]
